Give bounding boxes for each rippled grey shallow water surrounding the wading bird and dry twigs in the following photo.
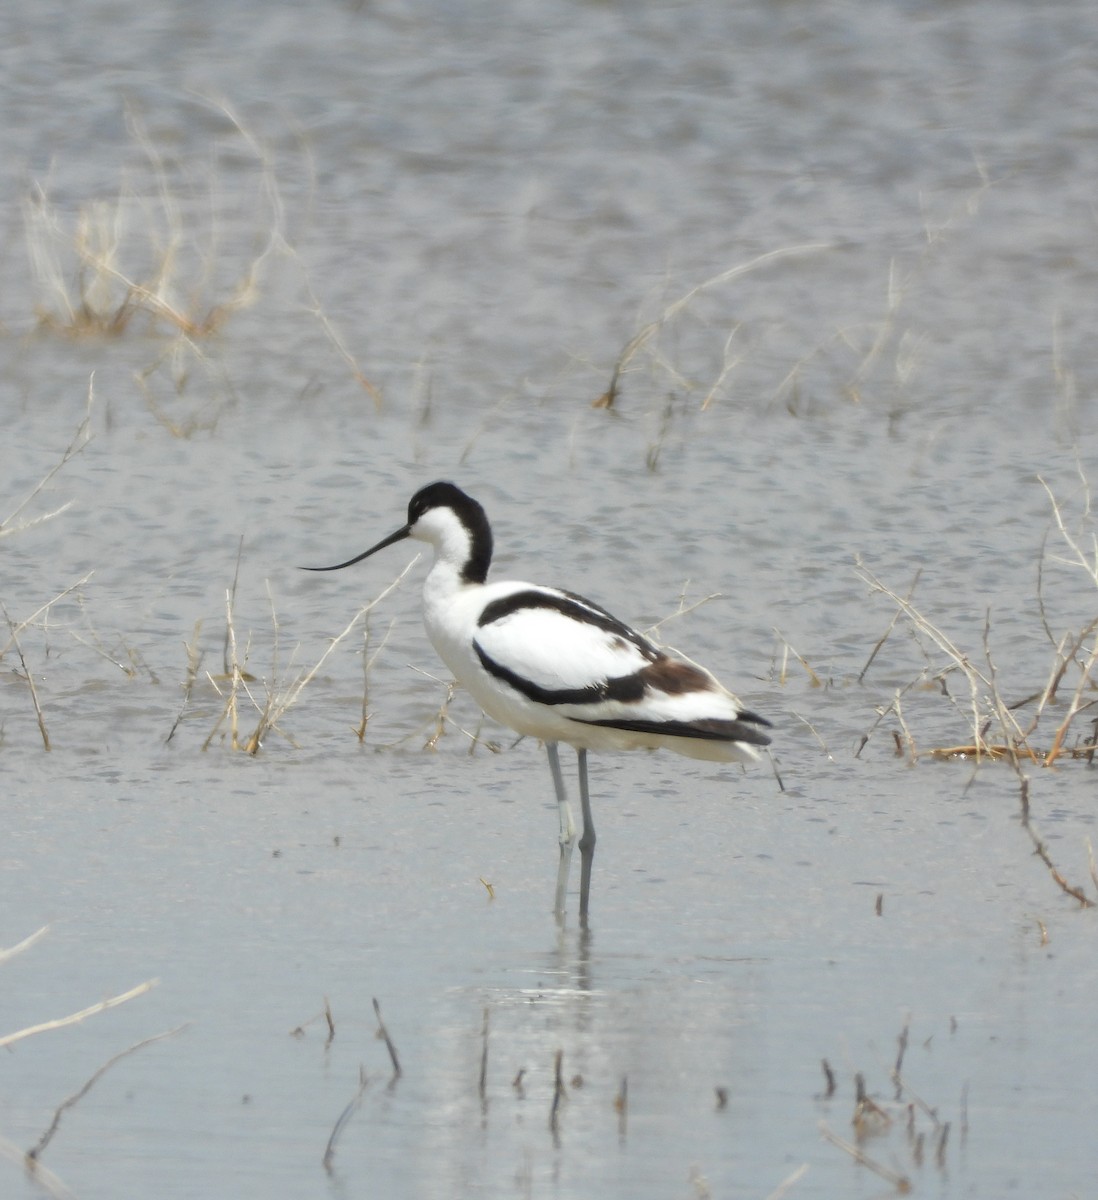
[0,2,1098,1200]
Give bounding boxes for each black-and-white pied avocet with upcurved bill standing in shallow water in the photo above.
[306,482,770,922]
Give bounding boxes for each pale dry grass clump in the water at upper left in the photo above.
[24,101,380,427]
